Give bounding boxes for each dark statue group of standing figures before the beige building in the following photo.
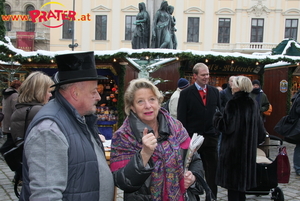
[131,1,177,49]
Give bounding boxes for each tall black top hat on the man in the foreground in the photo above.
[53,51,107,86]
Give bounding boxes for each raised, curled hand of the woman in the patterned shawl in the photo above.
[141,128,157,166]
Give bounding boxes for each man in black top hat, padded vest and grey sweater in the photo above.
[20,52,114,201]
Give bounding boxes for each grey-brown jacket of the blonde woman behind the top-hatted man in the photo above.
[11,103,43,142]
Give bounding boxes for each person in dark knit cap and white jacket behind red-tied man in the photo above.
[169,78,190,119]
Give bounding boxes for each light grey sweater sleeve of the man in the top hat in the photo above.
[24,120,69,201]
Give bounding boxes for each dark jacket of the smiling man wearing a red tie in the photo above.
[177,84,220,136]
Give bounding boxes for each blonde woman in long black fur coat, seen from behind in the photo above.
[213,76,265,201]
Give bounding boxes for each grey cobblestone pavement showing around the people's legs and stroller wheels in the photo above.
[0,137,300,201]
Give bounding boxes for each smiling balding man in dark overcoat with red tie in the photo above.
[177,63,220,197]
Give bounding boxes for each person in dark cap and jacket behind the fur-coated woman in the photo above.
[250,80,270,120]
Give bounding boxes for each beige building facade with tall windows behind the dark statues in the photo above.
[6,0,300,53]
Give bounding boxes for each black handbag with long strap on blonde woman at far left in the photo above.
[3,106,32,171]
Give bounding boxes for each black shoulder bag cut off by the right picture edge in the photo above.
[274,94,300,144]
